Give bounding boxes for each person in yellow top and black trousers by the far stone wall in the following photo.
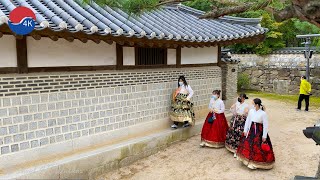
[297,76,311,111]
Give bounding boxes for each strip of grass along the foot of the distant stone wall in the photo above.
[246,91,320,108]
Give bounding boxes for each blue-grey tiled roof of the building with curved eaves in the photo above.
[0,0,267,42]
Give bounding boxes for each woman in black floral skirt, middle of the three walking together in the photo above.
[225,94,249,157]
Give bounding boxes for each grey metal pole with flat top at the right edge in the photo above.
[296,34,320,82]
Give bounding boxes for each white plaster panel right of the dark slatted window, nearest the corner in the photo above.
[181,46,218,64]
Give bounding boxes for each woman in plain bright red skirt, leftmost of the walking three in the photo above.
[200,90,228,148]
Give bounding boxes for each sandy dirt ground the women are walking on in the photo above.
[99,99,320,180]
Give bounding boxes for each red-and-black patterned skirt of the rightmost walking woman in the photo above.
[237,123,275,169]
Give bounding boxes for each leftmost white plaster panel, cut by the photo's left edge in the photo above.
[0,35,17,68]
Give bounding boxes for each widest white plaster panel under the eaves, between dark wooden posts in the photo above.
[27,37,116,67]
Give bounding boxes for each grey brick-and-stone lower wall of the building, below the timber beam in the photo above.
[0,66,221,169]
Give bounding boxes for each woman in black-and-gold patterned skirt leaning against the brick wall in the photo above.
[170,76,195,129]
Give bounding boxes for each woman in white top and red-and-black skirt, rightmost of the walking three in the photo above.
[237,98,275,169]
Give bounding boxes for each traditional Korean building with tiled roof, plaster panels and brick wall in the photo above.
[0,0,266,178]
